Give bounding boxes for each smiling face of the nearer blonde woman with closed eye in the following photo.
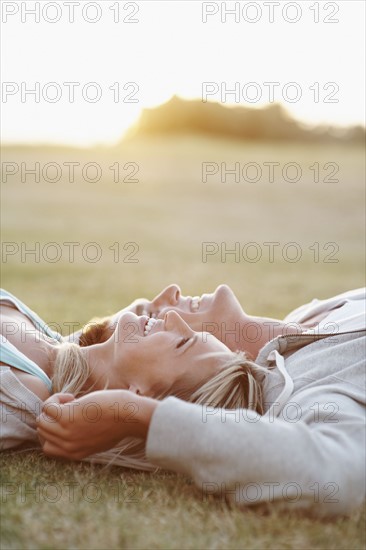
[95,311,230,396]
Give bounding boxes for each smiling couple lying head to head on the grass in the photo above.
[0,285,366,515]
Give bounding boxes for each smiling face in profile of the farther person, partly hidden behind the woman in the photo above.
[115,285,243,333]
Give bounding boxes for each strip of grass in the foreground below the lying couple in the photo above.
[1,453,365,550]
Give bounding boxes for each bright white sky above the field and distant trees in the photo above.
[1,0,365,145]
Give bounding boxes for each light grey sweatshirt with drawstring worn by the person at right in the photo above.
[147,291,366,515]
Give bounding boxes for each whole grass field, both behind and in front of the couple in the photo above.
[0,136,365,550]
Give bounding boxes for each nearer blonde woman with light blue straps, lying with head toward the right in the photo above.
[0,290,265,469]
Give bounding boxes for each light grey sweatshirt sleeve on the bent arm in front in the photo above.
[146,395,365,515]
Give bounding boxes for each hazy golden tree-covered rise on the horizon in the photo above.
[126,96,366,143]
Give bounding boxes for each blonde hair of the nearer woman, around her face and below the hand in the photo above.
[52,343,268,471]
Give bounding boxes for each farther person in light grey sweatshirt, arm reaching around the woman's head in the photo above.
[38,285,366,517]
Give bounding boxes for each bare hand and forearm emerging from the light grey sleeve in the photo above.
[37,390,158,460]
